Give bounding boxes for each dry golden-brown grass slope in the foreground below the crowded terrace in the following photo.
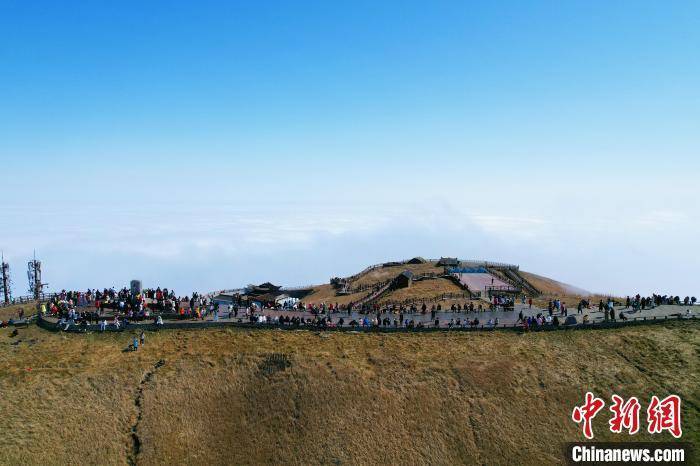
[0,321,700,464]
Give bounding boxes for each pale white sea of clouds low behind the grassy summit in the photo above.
[3,187,699,295]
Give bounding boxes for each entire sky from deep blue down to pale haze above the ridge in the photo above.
[0,1,700,294]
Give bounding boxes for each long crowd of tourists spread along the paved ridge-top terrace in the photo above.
[20,287,696,331]
